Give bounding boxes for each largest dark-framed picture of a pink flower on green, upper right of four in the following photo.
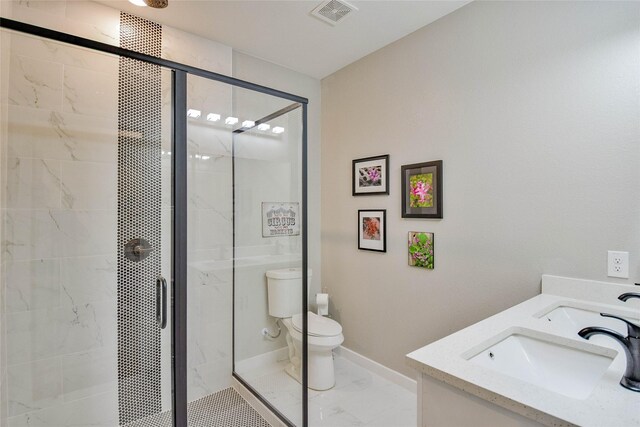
[401,160,442,218]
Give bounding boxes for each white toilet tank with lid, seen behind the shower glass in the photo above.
[267,268,311,318]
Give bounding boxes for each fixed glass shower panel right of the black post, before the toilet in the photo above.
[186,75,303,427]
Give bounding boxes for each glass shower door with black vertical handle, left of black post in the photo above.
[0,30,172,427]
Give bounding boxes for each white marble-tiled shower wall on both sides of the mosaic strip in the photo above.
[0,1,232,426]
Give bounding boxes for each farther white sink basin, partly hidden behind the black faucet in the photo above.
[539,305,638,343]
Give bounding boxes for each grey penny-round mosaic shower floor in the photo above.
[124,387,270,427]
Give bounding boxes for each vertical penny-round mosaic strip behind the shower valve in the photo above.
[117,13,162,425]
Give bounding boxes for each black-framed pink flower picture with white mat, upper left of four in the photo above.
[351,154,389,196]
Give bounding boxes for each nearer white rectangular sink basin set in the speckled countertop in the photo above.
[468,330,616,399]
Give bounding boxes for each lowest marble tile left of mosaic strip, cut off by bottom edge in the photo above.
[8,391,119,427]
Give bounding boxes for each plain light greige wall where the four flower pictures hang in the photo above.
[322,2,640,375]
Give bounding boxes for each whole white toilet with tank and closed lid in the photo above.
[267,268,344,390]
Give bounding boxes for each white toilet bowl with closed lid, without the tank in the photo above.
[282,312,344,391]
